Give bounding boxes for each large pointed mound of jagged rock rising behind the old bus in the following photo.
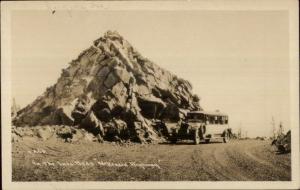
[13,31,201,142]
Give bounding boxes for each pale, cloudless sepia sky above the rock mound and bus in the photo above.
[11,10,290,136]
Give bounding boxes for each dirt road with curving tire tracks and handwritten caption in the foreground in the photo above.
[13,139,291,181]
